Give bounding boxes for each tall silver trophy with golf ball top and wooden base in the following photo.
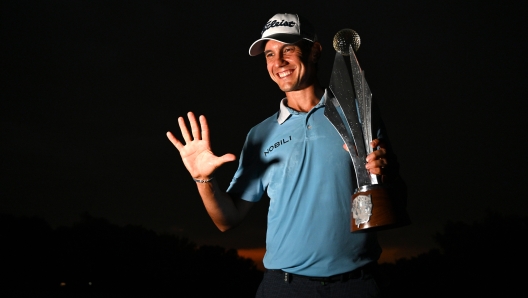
[325,29,410,232]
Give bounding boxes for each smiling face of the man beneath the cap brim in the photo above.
[264,40,316,92]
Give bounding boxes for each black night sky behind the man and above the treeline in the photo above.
[0,0,528,255]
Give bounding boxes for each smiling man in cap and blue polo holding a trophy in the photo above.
[167,14,396,297]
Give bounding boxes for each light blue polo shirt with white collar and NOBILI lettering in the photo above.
[227,89,381,276]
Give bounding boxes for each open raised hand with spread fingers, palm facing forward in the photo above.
[167,112,236,180]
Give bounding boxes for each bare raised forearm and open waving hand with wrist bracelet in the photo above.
[167,112,254,232]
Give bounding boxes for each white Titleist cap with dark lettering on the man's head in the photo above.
[249,13,317,56]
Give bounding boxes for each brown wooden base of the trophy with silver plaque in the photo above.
[350,184,411,232]
